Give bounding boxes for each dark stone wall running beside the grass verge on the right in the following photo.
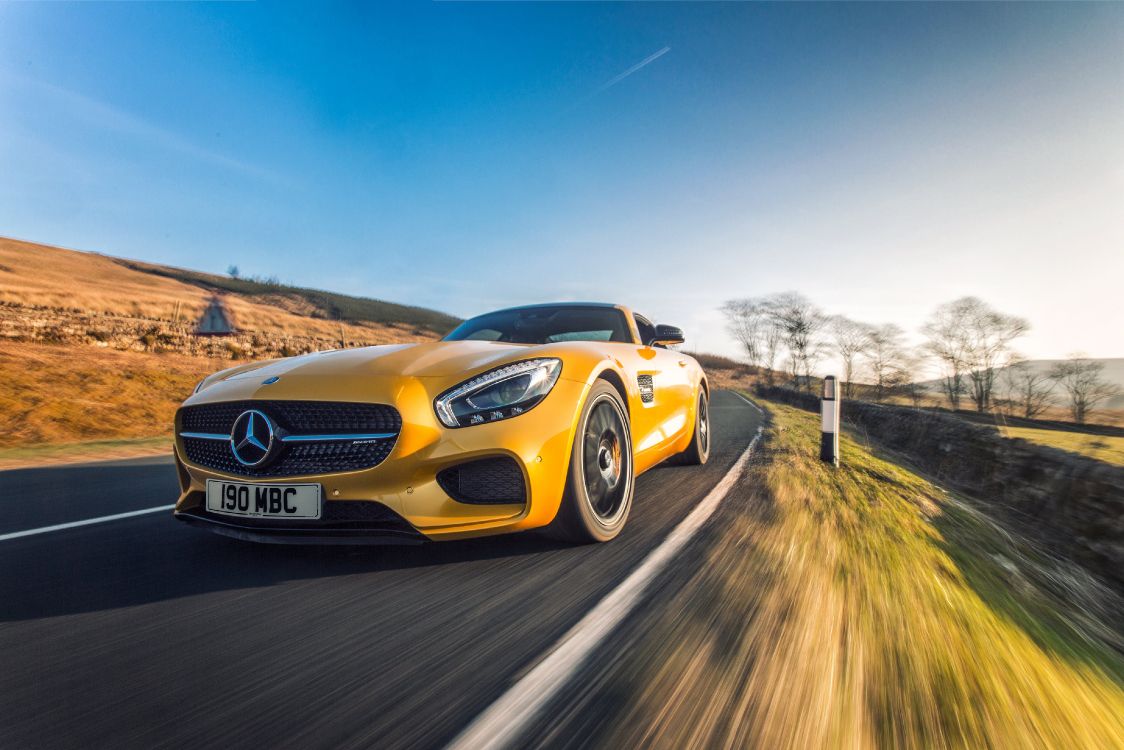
[758,387,1124,591]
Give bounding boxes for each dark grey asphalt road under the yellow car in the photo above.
[0,392,761,748]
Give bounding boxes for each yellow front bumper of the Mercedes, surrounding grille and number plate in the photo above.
[175,378,587,544]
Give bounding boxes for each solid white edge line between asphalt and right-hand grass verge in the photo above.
[448,427,762,750]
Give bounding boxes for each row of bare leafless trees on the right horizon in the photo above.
[720,291,1118,424]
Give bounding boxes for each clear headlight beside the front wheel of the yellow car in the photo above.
[434,359,562,427]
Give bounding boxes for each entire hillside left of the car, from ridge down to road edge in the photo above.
[0,238,457,466]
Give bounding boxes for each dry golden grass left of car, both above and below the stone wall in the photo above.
[0,238,447,458]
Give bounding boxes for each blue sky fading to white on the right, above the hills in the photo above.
[0,2,1124,356]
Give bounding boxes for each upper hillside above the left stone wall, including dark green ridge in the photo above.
[0,237,459,340]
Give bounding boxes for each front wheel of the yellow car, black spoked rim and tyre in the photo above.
[546,380,636,544]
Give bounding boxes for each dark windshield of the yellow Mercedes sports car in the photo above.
[444,305,633,344]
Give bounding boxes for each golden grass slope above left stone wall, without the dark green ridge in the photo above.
[0,237,436,344]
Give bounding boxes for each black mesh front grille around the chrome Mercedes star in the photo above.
[178,401,402,477]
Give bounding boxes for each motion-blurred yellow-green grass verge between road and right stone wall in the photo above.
[587,395,1124,750]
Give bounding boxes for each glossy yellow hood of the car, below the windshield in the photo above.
[220,341,536,381]
